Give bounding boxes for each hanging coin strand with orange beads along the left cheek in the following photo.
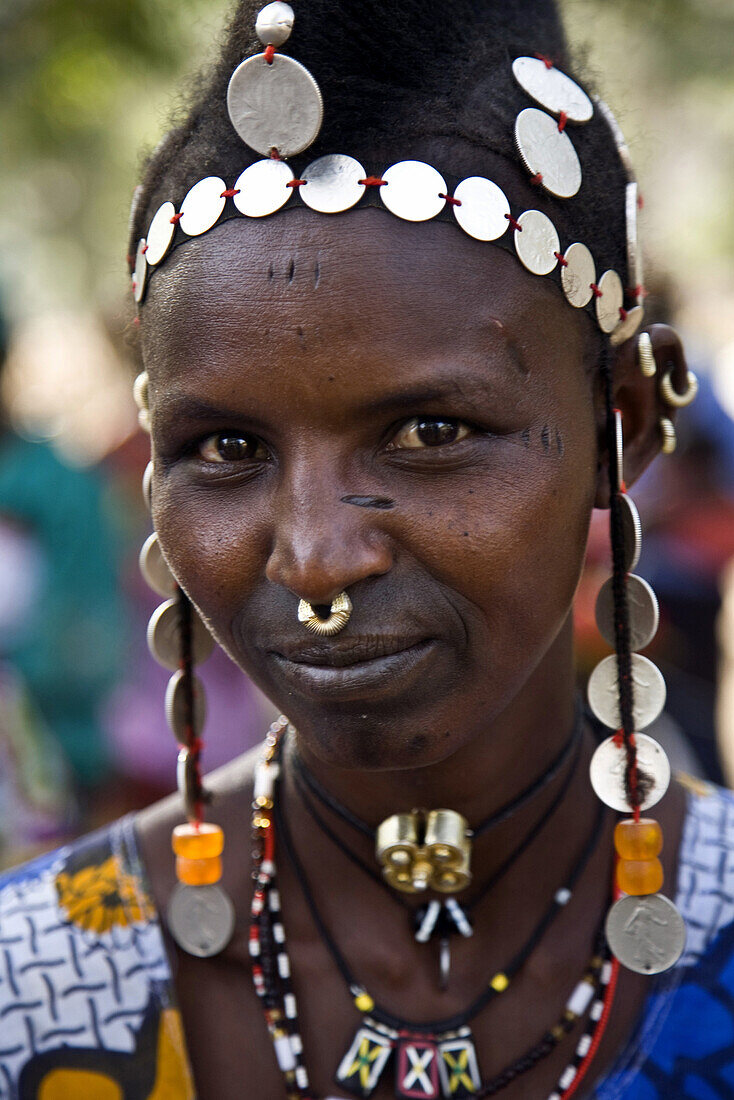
[136,420,234,958]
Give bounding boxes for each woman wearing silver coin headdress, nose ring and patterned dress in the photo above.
[0,0,733,1100]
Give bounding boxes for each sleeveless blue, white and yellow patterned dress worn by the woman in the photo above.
[0,788,734,1100]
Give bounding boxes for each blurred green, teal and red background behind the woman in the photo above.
[0,0,734,866]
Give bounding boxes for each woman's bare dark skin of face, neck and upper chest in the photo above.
[139,187,683,1100]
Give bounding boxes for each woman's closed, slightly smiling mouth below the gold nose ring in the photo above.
[269,636,438,699]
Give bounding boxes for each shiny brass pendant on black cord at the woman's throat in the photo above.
[376,810,471,893]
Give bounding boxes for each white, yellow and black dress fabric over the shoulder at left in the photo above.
[0,818,193,1100]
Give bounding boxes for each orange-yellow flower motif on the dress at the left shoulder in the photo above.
[56,856,155,933]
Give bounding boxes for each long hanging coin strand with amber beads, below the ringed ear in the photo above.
[588,409,686,975]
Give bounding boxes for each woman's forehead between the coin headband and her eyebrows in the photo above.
[141,208,585,396]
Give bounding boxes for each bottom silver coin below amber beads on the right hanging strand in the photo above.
[604,894,686,974]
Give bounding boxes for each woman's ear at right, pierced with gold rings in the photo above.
[594,325,688,508]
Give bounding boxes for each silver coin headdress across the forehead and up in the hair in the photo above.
[132,0,644,344]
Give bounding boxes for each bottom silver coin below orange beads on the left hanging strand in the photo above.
[166,882,234,958]
